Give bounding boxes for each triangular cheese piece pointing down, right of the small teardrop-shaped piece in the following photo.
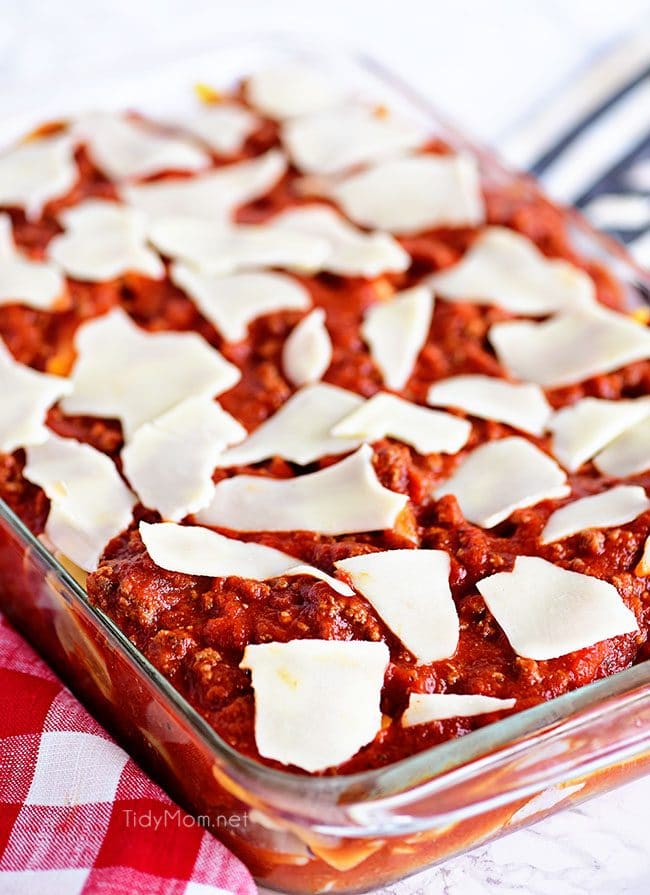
[361,286,433,390]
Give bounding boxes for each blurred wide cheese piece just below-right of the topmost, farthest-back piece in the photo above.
[281,103,426,174]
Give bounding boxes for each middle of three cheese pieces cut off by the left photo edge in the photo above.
[0,214,66,311]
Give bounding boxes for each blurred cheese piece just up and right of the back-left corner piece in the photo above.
[71,112,210,180]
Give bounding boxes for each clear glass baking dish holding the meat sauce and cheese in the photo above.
[0,37,650,893]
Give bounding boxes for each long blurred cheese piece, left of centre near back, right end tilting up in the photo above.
[120,149,287,221]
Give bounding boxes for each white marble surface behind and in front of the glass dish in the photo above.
[0,0,650,895]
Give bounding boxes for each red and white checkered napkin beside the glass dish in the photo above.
[0,615,255,895]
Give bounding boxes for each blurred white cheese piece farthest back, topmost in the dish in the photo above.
[245,65,341,119]
